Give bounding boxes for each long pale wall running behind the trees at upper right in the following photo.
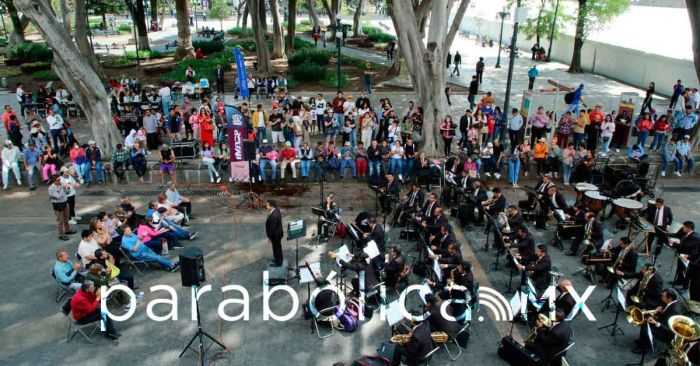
[461,17,700,95]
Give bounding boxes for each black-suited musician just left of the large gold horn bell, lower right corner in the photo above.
[632,289,685,354]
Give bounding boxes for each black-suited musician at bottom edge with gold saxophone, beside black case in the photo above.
[525,309,572,365]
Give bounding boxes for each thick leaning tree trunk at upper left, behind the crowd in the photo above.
[16,0,122,156]
